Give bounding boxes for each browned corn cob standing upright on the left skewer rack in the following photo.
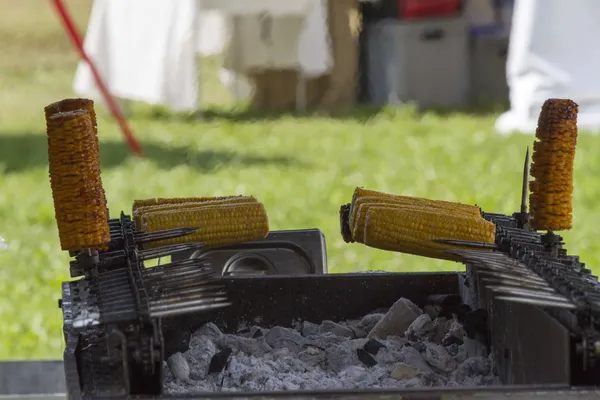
[45,104,110,251]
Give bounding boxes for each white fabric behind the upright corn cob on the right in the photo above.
[496,0,600,134]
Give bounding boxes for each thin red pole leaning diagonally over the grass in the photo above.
[52,0,142,155]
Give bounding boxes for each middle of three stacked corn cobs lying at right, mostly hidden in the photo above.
[350,196,481,243]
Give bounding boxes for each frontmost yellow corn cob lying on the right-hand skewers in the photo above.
[364,206,496,261]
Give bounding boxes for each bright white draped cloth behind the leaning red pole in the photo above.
[73,0,198,110]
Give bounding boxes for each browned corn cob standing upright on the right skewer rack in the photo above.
[529,99,579,231]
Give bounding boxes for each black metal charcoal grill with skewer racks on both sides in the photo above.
[27,100,600,400]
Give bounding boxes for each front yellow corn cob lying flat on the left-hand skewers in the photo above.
[142,202,269,247]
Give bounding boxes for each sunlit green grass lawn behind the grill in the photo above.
[0,0,600,359]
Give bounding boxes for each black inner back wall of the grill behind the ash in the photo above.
[163,272,459,333]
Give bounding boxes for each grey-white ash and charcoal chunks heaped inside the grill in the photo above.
[164,299,500,394]
